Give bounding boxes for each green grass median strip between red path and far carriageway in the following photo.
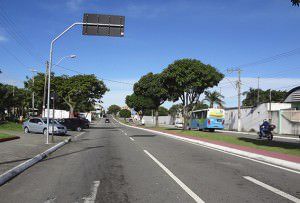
[146,127,300,156]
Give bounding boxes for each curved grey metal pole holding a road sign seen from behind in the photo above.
[46,13,125,144]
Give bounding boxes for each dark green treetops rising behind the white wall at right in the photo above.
[242,88,287,106]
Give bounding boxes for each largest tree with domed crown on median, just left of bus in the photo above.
[161,59,224,129]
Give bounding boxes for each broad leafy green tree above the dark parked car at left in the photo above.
[52,75,109,116]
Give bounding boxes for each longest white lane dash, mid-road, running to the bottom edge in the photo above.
[144,150,204,203]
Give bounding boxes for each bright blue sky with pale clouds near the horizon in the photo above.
[0,0,300,107]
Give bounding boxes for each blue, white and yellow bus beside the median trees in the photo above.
[188,108,225,132]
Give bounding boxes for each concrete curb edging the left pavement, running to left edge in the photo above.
[0,138,71,186]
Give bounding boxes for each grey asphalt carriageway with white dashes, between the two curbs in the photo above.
[0,117,300,203]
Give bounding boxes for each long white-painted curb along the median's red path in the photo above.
[114,118,300,174]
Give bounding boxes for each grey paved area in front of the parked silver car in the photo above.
[0,131,71,174]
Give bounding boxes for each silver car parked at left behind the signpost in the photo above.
[23,118,67,135]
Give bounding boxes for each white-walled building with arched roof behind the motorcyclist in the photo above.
[224,86,300,136]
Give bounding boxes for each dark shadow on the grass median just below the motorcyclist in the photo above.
[238,137,300,150]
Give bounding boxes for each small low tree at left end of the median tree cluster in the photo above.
[125,93,155,118]
